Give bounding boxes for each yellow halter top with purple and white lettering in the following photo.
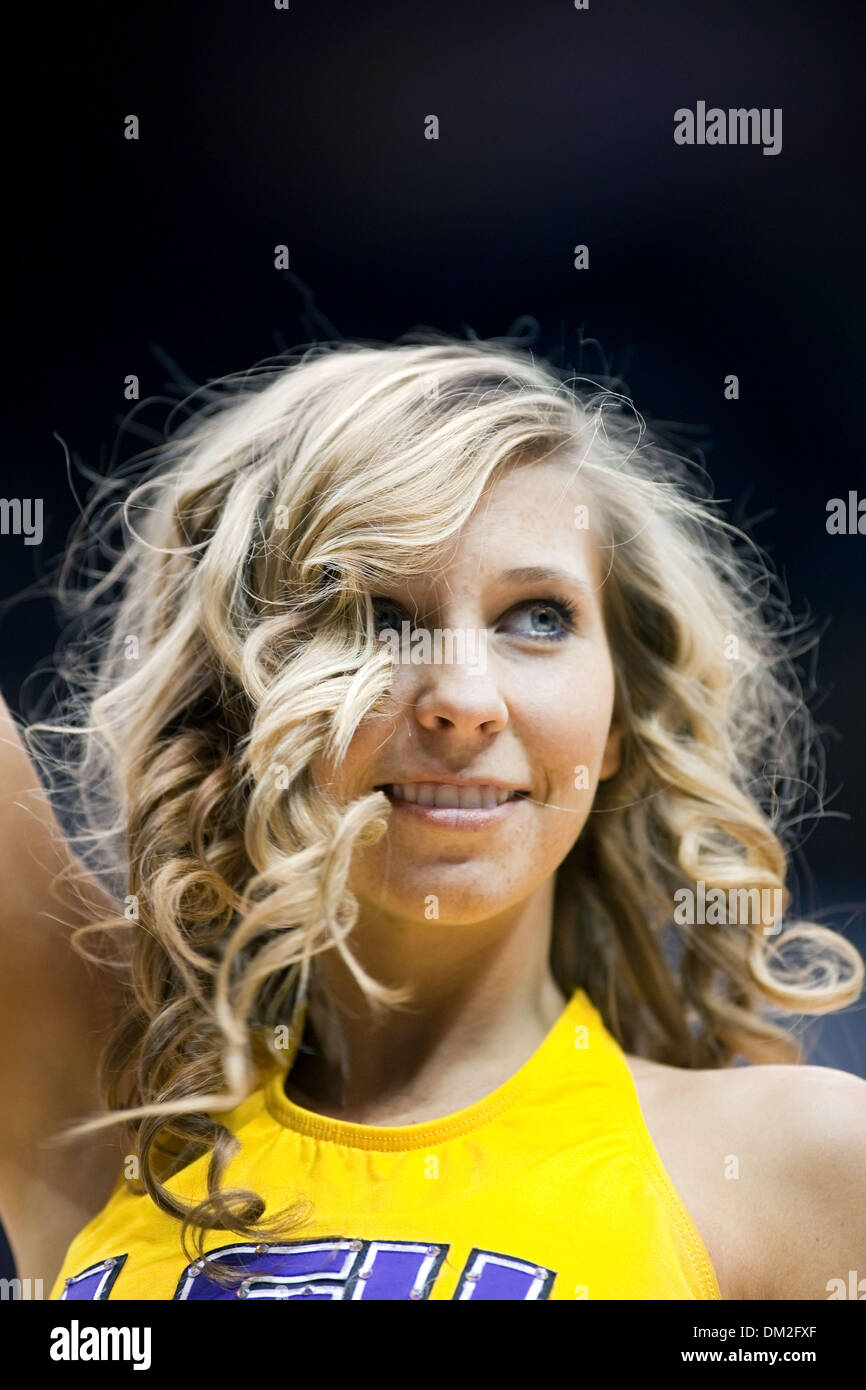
[50,990,721,1301]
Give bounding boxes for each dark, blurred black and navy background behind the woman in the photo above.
[0,0,866,1293]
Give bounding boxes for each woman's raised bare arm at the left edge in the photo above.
[0,698,129,1262]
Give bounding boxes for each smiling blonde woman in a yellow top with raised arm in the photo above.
[0,336,866,1301]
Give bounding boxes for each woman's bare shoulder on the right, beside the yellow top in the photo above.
[627,1056,866,1298]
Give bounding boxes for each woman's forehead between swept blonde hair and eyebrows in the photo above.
[430,457,602,588]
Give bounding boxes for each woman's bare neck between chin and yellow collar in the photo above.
[286,884,567,1123]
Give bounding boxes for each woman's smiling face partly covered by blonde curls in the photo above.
[315,461,620,923]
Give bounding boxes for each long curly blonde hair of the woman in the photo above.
[29,334,863,1258]
